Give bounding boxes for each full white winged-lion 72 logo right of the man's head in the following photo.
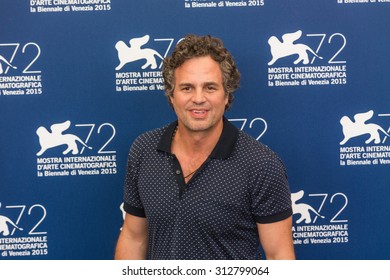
[268,30,347,87]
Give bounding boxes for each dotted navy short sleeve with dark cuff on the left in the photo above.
[123,138,145,217]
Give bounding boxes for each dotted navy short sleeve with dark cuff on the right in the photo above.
[252,150,292,223]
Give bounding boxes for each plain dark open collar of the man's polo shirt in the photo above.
[157,117,238,159]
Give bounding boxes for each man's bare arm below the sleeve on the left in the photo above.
[115,214,148,260]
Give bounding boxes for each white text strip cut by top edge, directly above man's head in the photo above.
[184,0,265,9]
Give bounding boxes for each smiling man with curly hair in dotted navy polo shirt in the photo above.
[115,35,295,259]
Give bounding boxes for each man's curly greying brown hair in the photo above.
[162,34,240,110]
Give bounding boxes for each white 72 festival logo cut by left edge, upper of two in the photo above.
[0,42,43,96]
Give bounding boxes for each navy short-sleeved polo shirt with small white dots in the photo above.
[124,120,292,259]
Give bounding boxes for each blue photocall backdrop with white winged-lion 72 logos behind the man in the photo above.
[0,0,390,260]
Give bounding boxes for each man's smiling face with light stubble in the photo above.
[170,56,228,135]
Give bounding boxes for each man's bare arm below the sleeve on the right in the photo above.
[257,217,295,260]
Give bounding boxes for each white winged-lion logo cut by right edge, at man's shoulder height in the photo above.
[340,110,390,166]
